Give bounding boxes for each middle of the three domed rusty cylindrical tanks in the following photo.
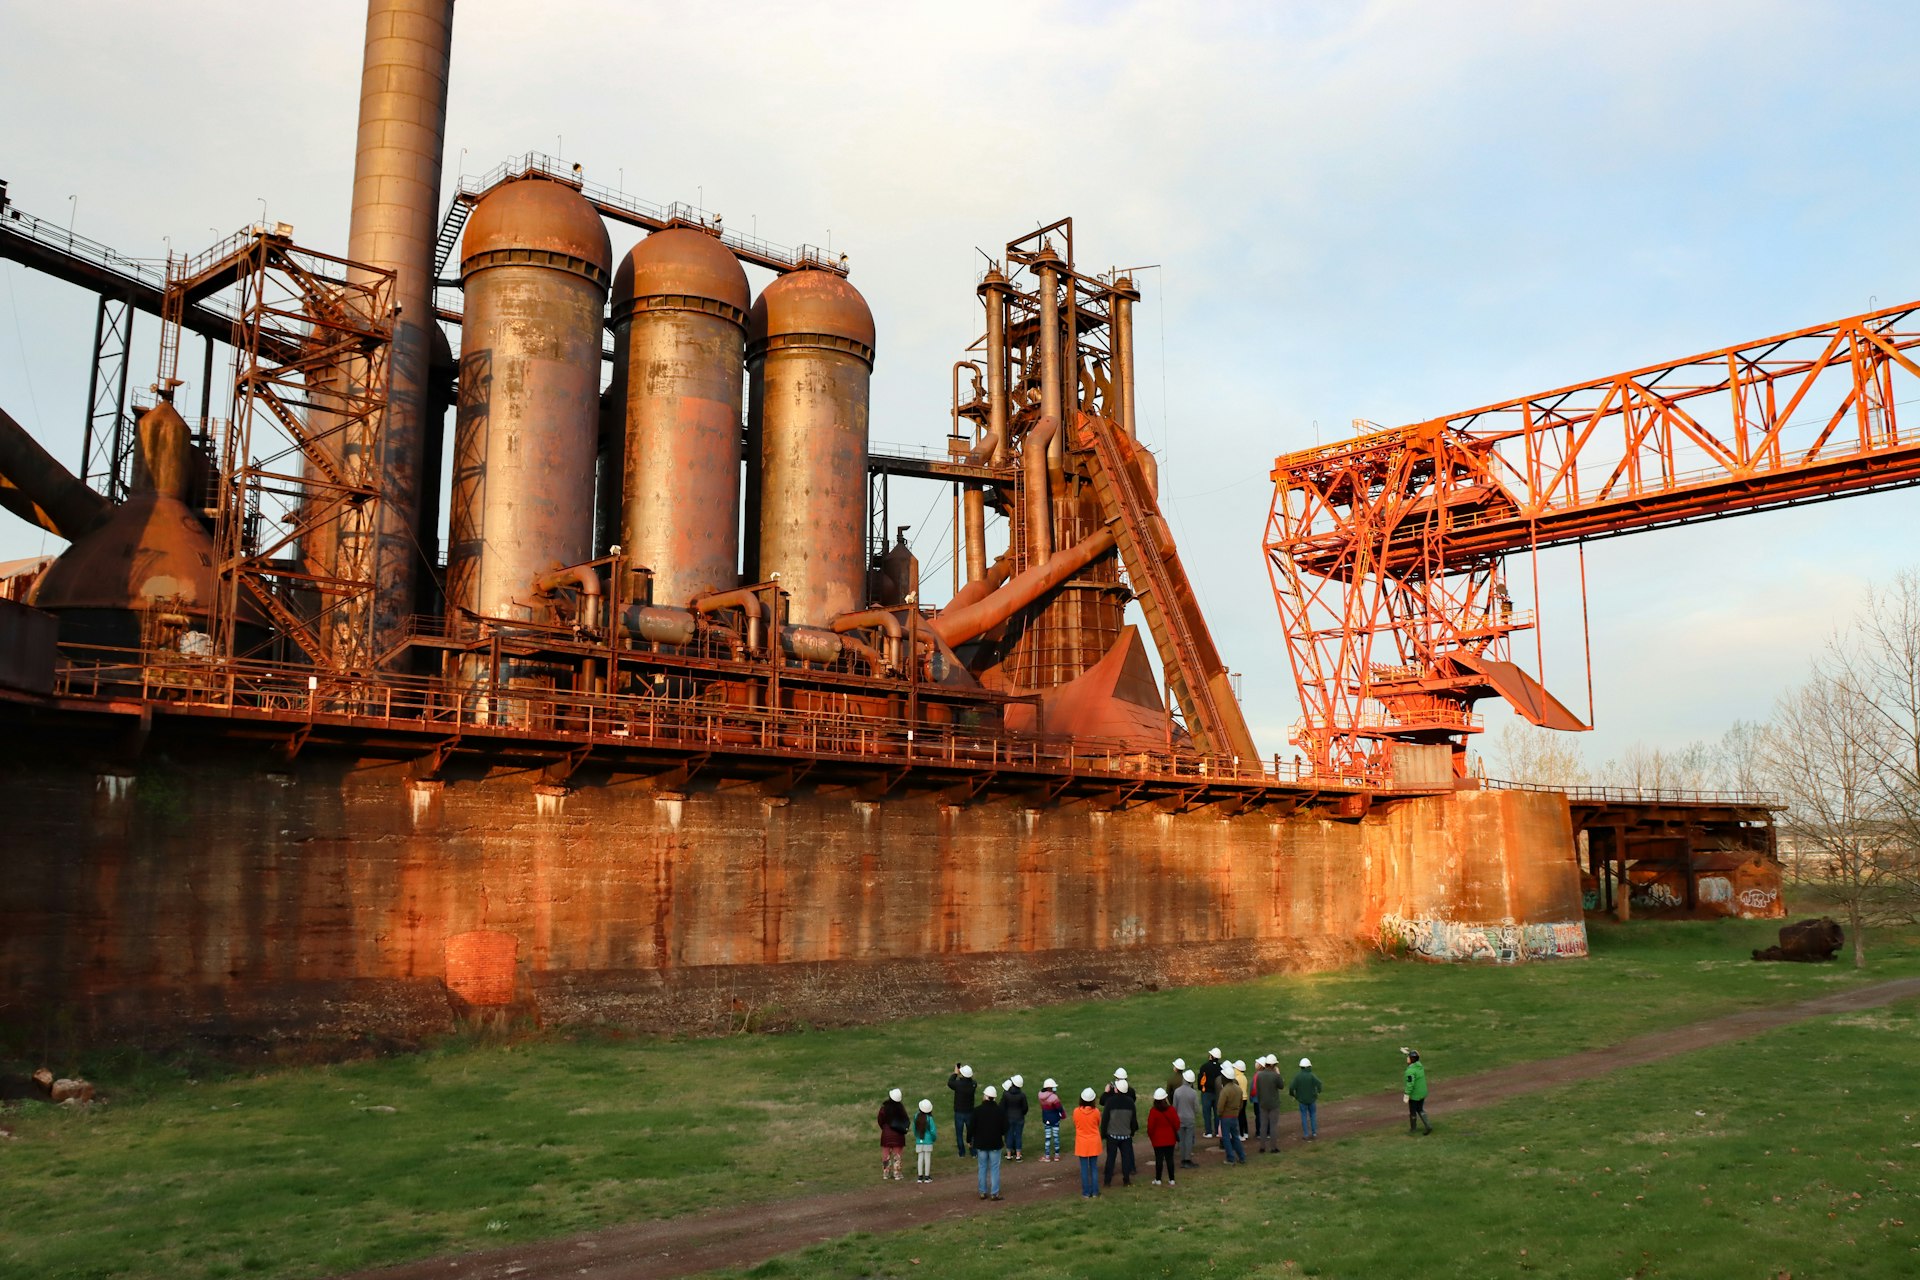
[612,226,751,606]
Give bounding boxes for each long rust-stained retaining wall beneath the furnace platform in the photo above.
[0,754,1584,1038]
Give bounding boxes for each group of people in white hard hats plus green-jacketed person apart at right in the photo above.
[879,1048,1432,1199]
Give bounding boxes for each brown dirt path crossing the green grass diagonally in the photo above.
[341,979,1920,1280]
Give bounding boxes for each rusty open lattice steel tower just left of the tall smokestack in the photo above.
[161,226,394,670]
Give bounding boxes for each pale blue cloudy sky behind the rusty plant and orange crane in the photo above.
[0,0,1920,760]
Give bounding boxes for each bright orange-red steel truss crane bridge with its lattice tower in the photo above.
[1265,301,1920,785]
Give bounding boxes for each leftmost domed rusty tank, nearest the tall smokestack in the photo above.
[447,177,612,618]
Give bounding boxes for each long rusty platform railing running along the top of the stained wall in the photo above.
[56,647,1428,791]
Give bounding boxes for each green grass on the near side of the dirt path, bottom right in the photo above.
[721,1000,1920,1280]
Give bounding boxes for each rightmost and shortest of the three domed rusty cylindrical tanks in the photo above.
[747,271,874,626]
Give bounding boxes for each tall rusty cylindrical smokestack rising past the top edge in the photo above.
[348,0,453,654]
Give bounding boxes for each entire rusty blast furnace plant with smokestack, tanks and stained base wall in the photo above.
[0,0,1584,1038]
